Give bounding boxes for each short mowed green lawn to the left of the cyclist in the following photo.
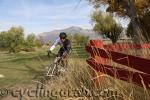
[0,48,86,87]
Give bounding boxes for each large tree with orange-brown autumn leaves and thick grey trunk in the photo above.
[88,0,150,44]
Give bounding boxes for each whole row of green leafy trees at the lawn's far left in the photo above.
[0,26,44,52]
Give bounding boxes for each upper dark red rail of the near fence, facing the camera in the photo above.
[86,46,150,74]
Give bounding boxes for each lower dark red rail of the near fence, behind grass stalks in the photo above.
[87,58,150,89]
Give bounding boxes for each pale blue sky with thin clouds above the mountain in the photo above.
[0,0,127,34]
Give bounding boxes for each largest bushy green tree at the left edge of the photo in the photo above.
[0,27,24,52]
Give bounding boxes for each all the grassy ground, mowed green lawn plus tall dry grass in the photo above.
[0,44,150,100]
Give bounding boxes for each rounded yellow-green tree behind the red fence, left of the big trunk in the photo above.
[91,10,123,43]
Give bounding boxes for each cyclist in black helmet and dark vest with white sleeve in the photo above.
[48,32,71,69]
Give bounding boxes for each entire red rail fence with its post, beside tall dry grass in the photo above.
[85,40,150,88]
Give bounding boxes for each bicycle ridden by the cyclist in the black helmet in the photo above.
[44,53,67,78]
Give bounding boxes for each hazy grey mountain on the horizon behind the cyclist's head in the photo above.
[38,26,102,42]
